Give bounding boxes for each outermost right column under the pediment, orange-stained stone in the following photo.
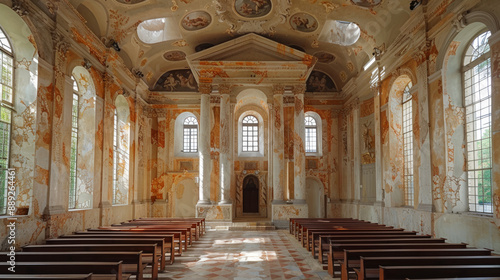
[293,84,306,204]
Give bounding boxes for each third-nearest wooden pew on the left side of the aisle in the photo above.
[0,251,146,280]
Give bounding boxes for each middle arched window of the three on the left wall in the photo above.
[68,76,79,209]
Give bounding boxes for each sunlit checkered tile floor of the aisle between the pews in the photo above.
[159,230,333,280]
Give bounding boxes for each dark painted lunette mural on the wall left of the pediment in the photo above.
[154,70,198,91]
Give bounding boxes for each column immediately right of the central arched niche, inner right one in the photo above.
[271,85,287,204]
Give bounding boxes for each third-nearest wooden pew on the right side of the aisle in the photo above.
[340,248,491,280]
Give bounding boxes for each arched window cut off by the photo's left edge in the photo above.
[0,28,14,214]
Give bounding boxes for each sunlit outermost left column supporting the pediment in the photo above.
[198,83,212,204]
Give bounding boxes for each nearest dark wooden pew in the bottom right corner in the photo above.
[379,265,500,280]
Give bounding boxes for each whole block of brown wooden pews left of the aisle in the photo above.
[0,218,205,280]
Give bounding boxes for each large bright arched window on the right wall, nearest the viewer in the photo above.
[462,31,493,213]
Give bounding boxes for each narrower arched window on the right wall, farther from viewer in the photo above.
[403,82,414,206]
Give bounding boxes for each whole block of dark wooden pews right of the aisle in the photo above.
[289,218,500,280]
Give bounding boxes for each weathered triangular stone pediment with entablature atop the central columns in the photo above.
[186,33,317,85]
